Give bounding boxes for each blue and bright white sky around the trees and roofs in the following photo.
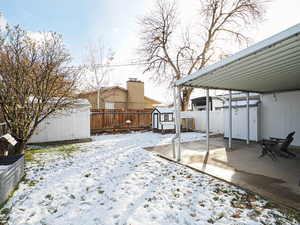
[0,0,300,102]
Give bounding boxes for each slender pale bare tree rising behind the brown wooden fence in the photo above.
[85,39,114,109]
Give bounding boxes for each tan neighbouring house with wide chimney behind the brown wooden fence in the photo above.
[79,78,161,110]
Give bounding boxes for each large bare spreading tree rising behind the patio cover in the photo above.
[139,0,266,110]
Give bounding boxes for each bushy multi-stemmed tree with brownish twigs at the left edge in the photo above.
[0,26,80,154]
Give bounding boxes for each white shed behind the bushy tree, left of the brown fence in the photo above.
[29,99,91,143]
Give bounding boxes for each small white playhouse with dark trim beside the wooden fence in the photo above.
[152,107,175,133]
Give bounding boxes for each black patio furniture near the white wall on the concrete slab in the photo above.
[259,131,296,160]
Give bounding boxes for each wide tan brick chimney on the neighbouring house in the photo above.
[127,78,144,109]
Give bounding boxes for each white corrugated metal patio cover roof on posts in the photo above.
[176,24,300,93]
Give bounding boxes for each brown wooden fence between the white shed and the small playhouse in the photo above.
[91,109,152,134]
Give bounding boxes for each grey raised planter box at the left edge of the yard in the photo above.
[0,155,25,206]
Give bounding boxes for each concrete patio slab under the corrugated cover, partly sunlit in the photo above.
[146,137,300,210]
